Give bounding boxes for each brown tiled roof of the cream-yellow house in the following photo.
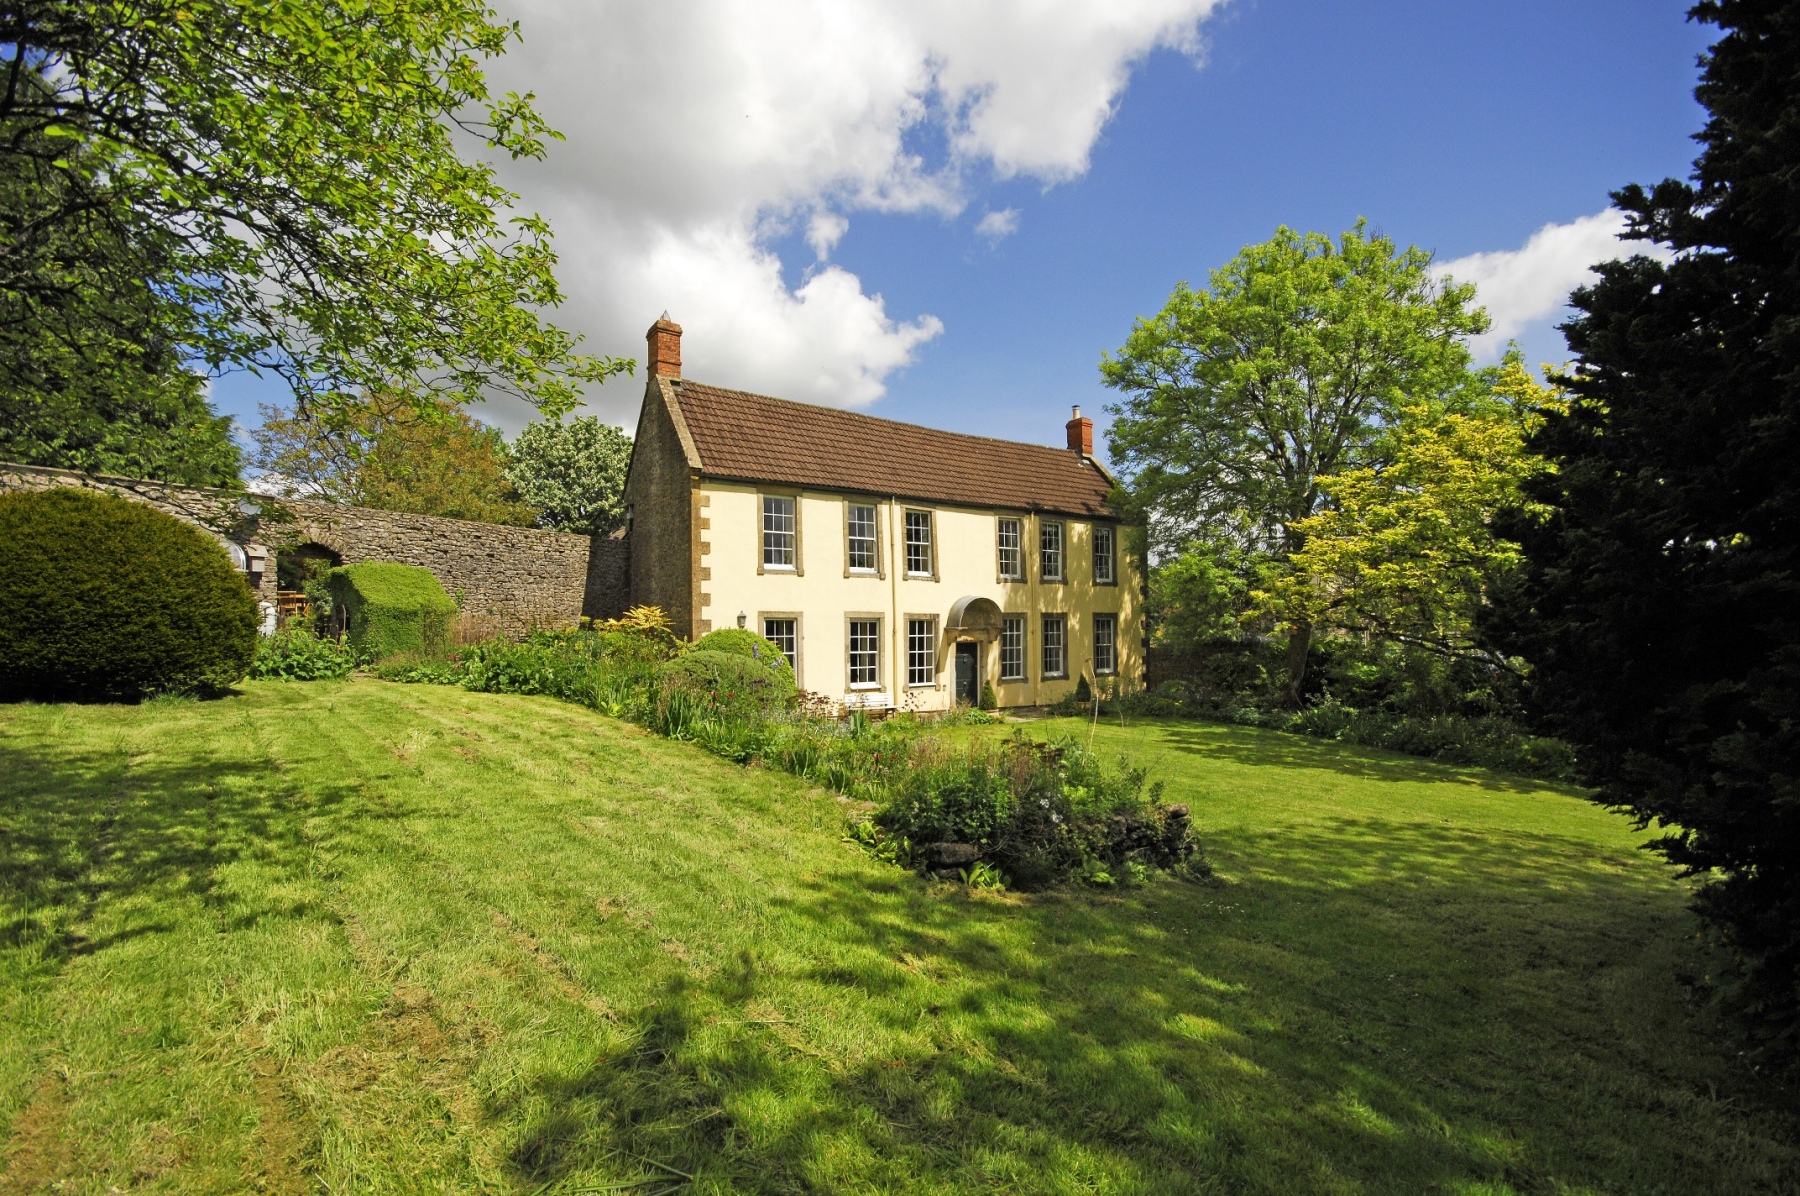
[675,382,1112,517]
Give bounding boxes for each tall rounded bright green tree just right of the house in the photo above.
[1100,223,1487,701]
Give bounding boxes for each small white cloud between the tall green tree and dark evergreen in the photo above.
[1435,207,1654,362]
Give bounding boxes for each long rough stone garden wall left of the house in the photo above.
[0,463,630,636]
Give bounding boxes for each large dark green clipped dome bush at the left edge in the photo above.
[0,486,257,701]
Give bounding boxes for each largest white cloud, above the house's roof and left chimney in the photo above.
[490,0,1224,420]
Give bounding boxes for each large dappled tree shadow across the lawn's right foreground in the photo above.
[515,820,1800,1192]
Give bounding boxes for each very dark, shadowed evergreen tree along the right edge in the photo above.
[1496,0,1800,1050]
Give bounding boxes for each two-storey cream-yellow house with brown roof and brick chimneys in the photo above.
[625,317,1145,711]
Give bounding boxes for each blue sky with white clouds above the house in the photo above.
[214,0,1712,468]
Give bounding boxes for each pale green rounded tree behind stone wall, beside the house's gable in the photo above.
[506,416,632,535]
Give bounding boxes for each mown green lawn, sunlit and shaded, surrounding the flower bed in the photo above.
[0,681,1800,1196]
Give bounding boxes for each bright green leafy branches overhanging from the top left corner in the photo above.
[0,0,625,425]
